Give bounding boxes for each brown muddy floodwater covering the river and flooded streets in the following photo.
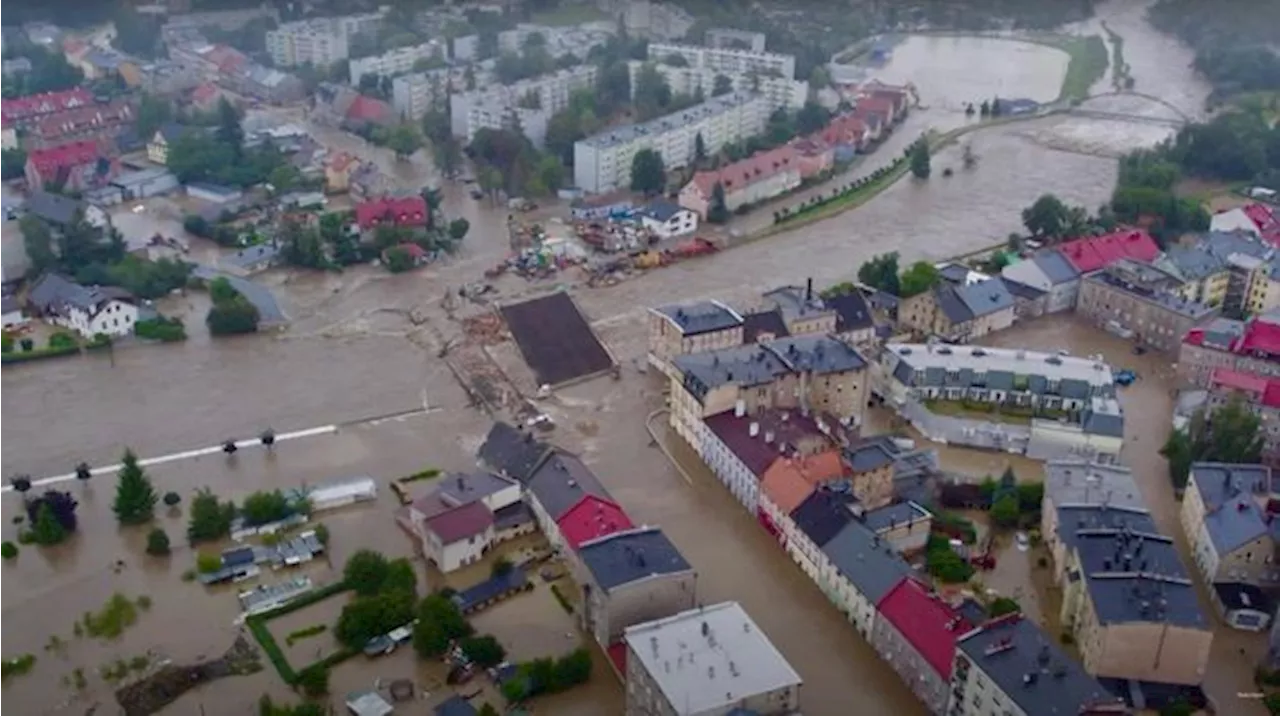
[0,3,1247,716]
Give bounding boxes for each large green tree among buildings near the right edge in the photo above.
[1160,398,1265,489]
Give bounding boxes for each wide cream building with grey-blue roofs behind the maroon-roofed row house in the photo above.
[671,336,867,446]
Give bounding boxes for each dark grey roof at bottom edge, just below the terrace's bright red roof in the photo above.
[956,616,1119,716]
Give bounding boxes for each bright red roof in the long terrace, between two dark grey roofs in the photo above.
[876,576,973,681]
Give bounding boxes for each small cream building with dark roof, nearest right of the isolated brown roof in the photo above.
[649,301,742,375]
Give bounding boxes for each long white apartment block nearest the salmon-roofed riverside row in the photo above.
[573,92,769,193]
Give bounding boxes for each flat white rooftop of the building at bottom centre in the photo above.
[623,602,801,713]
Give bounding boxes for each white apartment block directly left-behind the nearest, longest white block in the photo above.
[449,64,598,149]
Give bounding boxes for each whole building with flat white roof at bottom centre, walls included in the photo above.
[623,602,803,716]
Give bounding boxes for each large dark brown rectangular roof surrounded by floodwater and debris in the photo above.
[502,291,614,386]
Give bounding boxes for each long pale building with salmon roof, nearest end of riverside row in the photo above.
[680,140,801,219]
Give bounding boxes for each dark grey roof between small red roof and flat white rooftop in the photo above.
[577,528,692,590]
